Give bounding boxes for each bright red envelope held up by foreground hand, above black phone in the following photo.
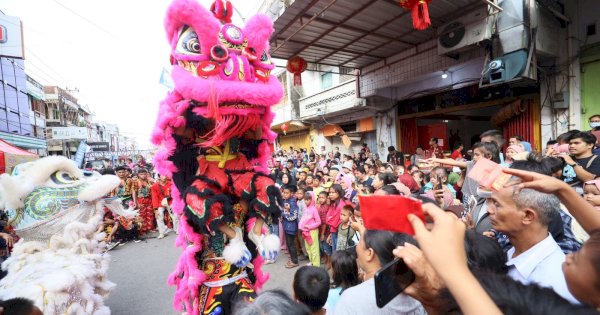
[358,195,425,235]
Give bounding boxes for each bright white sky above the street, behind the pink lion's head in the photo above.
[0,0,263,148]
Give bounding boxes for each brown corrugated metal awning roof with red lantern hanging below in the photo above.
[271,0,485,68]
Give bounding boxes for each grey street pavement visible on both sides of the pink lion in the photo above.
[105,233,298,315]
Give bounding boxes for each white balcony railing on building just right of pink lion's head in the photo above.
[300,80,363,119]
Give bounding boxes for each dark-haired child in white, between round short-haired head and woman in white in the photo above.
[325,251,360,314]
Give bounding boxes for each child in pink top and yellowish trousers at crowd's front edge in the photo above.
[298,192,321,267]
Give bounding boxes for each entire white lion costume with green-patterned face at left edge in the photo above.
[0,157,130,315]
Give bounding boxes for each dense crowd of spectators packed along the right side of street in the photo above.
[236,116,600,314]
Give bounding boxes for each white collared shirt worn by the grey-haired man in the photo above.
[506,233,579,304]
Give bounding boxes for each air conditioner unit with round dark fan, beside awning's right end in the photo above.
[438,6,493,55]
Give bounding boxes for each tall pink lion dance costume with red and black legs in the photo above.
[152,0,283,314]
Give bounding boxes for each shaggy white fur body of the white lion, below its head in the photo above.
[0,209,115,315]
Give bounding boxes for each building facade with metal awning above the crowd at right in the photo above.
[265,0,600,155]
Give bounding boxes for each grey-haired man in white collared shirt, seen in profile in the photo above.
[488,181,579,303]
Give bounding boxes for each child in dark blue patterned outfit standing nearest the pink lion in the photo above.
[281,185,298,268]
